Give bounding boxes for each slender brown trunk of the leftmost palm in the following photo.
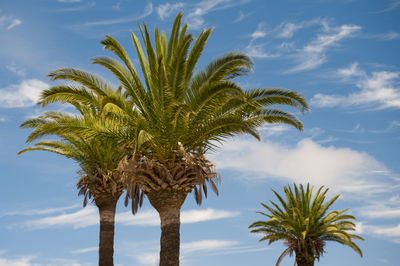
[96,198,118,266]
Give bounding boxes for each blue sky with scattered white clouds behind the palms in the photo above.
[0,0,400,266]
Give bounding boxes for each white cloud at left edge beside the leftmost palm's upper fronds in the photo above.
[0,79,49,108]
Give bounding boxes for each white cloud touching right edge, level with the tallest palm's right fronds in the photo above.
[311,63,400,109]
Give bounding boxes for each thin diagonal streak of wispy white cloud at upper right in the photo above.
[288,25,361,73]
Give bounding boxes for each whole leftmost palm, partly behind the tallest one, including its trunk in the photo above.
[19,72,143,266]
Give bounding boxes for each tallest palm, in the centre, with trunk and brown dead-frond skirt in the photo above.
[33,13,308,266]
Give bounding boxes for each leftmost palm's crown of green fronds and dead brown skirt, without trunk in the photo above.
[19,74,143,213]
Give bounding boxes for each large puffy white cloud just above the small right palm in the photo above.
[211,139,390,194]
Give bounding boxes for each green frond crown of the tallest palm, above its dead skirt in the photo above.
[93,13,308,159]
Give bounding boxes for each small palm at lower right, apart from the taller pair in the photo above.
[249,184,364,266]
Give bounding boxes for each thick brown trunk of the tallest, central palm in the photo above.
[147,189,187,266]
